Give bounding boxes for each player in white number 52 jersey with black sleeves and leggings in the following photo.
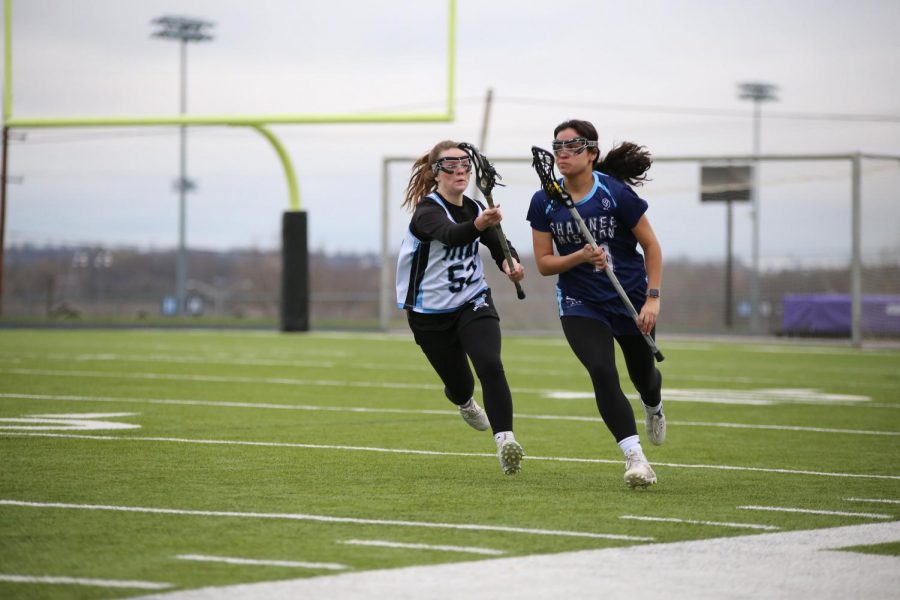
[397,140,525,475]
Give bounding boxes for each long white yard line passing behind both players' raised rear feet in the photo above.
[0,392,900,436]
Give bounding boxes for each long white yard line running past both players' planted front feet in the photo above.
[0,431,900,480]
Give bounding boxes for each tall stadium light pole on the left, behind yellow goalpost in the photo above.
[151,16,213,315]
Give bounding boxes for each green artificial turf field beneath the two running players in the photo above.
[0,330,900,599]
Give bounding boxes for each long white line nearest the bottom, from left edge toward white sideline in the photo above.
[0,500,654,542]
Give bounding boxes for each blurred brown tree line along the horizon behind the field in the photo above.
[2,245,900,333]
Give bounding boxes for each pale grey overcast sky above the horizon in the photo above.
[6,0,900,260]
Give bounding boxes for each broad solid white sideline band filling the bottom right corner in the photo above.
[126,521,900,600]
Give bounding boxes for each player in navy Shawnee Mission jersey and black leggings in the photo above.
[528,120,666,487]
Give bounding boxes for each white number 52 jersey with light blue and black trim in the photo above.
[397,193,488,314]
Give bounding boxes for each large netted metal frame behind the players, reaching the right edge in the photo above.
[379,154,900,342]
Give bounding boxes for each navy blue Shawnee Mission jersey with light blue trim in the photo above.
[527,171,647,315]
